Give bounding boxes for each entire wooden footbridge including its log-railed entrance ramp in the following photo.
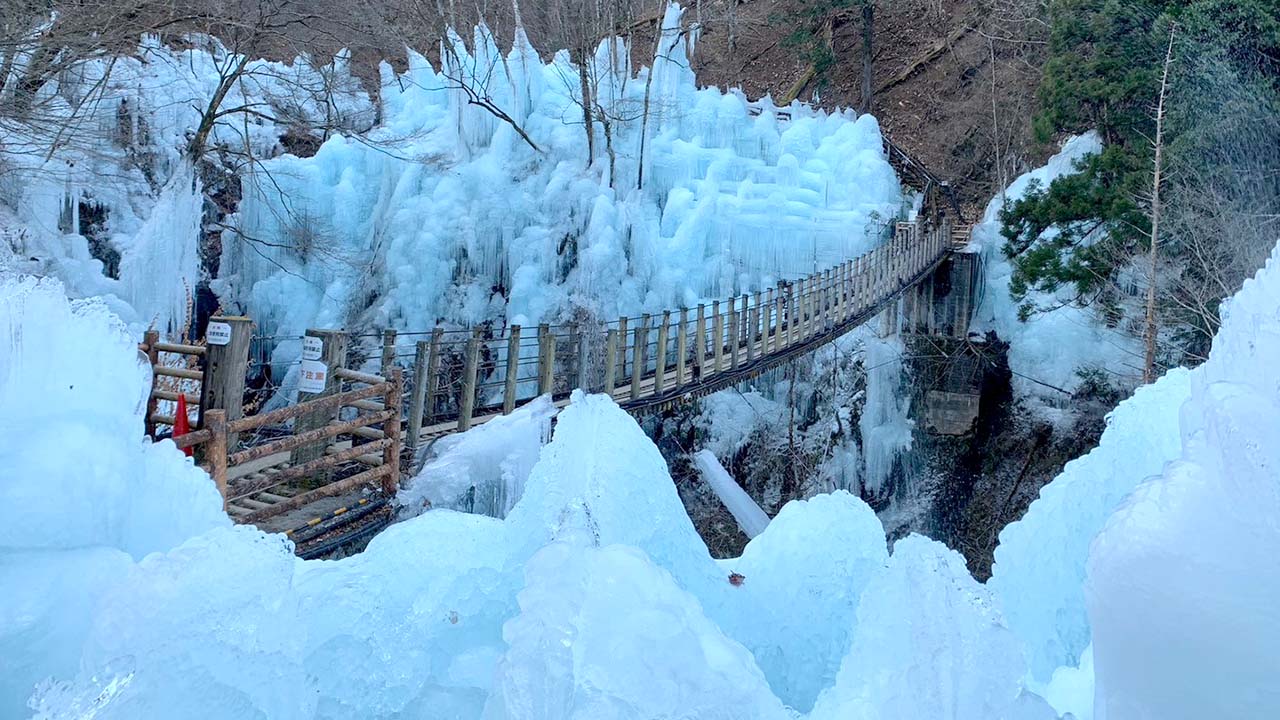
[143,215,968,550]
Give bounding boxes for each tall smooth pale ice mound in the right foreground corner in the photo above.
[1085,243,1280,720]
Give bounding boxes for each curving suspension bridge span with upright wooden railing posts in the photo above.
[383,222,968,435]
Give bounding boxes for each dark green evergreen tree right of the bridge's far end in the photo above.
[1001,0,1280,348]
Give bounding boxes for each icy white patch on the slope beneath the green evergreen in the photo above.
[973,133,1140,400]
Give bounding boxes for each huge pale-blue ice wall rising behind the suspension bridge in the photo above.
[220,5,902,354]
